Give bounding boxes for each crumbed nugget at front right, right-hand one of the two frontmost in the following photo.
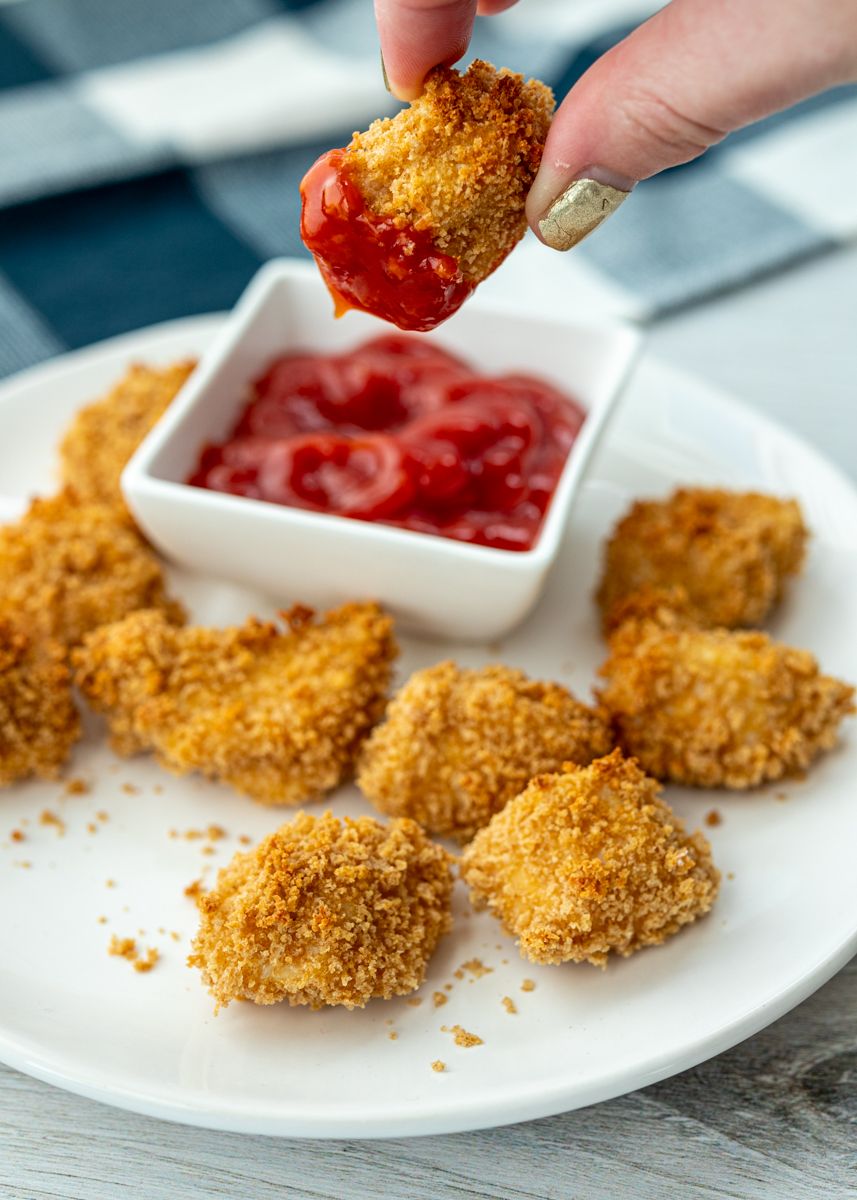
[461,750,720,966]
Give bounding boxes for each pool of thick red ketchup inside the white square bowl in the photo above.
[188,334,585,550]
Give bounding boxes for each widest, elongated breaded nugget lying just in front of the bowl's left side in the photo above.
[73,604,396,804]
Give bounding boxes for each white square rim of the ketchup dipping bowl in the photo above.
[120,258,643,574]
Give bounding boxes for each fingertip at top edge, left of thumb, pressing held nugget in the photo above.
[374,0,477,100]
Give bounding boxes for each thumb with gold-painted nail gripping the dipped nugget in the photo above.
[527,0,857,250]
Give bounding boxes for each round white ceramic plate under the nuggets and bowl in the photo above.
[0,318,857,1138]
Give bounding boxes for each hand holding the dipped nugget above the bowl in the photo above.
[376,0,857,250]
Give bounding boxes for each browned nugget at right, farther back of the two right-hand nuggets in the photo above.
[598,487,808,629]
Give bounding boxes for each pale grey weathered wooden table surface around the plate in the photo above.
[0,243,857,1200]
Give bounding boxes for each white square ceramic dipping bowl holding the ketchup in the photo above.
[122,259,641,641]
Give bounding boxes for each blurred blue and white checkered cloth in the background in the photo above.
[0,0,857,374]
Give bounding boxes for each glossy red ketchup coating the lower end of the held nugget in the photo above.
[300,150,474,331]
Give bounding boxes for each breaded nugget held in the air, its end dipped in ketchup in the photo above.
[301,60,553,330]
